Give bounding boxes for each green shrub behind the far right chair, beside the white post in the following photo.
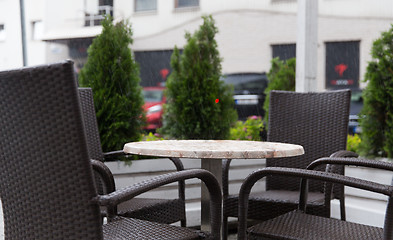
[263,57,296,124]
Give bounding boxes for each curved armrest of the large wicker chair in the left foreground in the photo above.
[93,169,222,237]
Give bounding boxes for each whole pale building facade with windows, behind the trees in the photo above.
[0,0,393,91]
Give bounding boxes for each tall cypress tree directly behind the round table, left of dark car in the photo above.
[160,16,237,139]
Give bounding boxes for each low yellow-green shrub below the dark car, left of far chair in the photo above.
[230,116,263,141]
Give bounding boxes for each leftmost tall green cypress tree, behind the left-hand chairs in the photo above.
[79,17,145,151]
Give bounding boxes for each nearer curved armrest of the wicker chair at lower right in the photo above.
[238,167,393,239]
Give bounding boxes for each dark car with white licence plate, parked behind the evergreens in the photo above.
[222,73,268,121]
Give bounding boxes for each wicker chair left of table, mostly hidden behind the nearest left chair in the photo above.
[78,88,186,227]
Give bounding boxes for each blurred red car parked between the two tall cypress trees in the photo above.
[142,87,166,131]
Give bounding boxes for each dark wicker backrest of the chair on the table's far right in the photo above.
[266,89,351,191]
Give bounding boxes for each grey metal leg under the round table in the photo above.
[201,159,222,234]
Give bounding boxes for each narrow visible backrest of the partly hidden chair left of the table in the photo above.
[78,88,104,161]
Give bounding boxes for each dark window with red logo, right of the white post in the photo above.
[326,41,360,89]
